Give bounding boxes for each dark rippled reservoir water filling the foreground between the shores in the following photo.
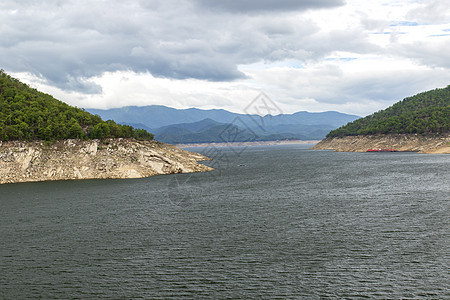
[0,145,450,299]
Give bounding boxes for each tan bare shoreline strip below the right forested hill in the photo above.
[311,134,450,154]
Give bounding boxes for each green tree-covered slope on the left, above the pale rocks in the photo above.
[0,70,153,141]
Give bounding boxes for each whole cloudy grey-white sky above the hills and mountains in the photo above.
[0,0,450,116]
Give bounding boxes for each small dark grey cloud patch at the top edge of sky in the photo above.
[193,0,344,13]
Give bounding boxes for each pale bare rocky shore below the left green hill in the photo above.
[0,139,212,184]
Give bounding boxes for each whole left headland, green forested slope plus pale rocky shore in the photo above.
[0,71,212,184]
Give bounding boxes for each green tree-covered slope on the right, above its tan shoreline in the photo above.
[327,85,450,137]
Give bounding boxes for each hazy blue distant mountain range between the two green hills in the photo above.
[87,105,359,144]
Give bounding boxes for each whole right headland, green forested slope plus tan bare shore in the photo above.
[311,86,450,153]
